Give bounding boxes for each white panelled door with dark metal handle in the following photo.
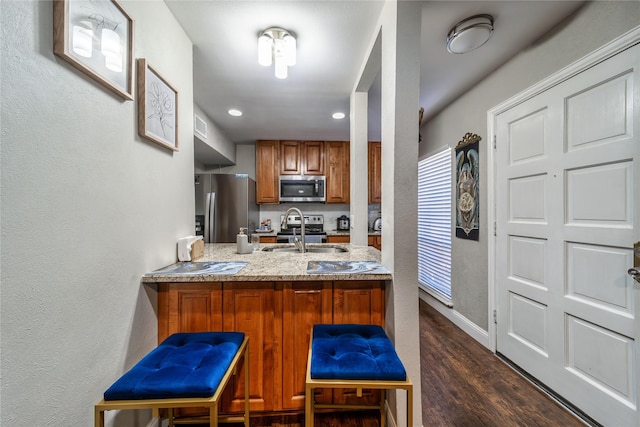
[495,41,640,426]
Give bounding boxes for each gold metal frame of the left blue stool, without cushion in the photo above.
[94,336,249,427]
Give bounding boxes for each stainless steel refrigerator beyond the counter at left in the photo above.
[195,174,260,243]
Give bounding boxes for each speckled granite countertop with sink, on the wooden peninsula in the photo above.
[142,243,392,283]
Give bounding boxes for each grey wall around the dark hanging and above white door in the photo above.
[420,1,640,330]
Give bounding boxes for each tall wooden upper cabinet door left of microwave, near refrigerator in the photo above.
[256,141,280,203]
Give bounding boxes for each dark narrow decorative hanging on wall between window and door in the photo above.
[456,132,482,240]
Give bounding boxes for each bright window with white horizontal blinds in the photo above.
[418,147,453,304]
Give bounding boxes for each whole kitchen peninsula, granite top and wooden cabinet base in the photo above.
[142,243,392,414]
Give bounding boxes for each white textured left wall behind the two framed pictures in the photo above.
[0,0,194,427]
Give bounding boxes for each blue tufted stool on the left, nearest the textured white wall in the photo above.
[95,332,249,427]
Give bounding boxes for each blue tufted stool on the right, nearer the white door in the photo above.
[305,324,413,427]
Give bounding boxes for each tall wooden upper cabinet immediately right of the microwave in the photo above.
[325,141,350,203]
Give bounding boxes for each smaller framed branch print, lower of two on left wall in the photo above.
[138,58,178,151]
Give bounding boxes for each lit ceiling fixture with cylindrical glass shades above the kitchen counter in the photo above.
[258,27,296,79]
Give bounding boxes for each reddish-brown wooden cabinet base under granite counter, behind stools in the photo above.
[158,280,385,415]
